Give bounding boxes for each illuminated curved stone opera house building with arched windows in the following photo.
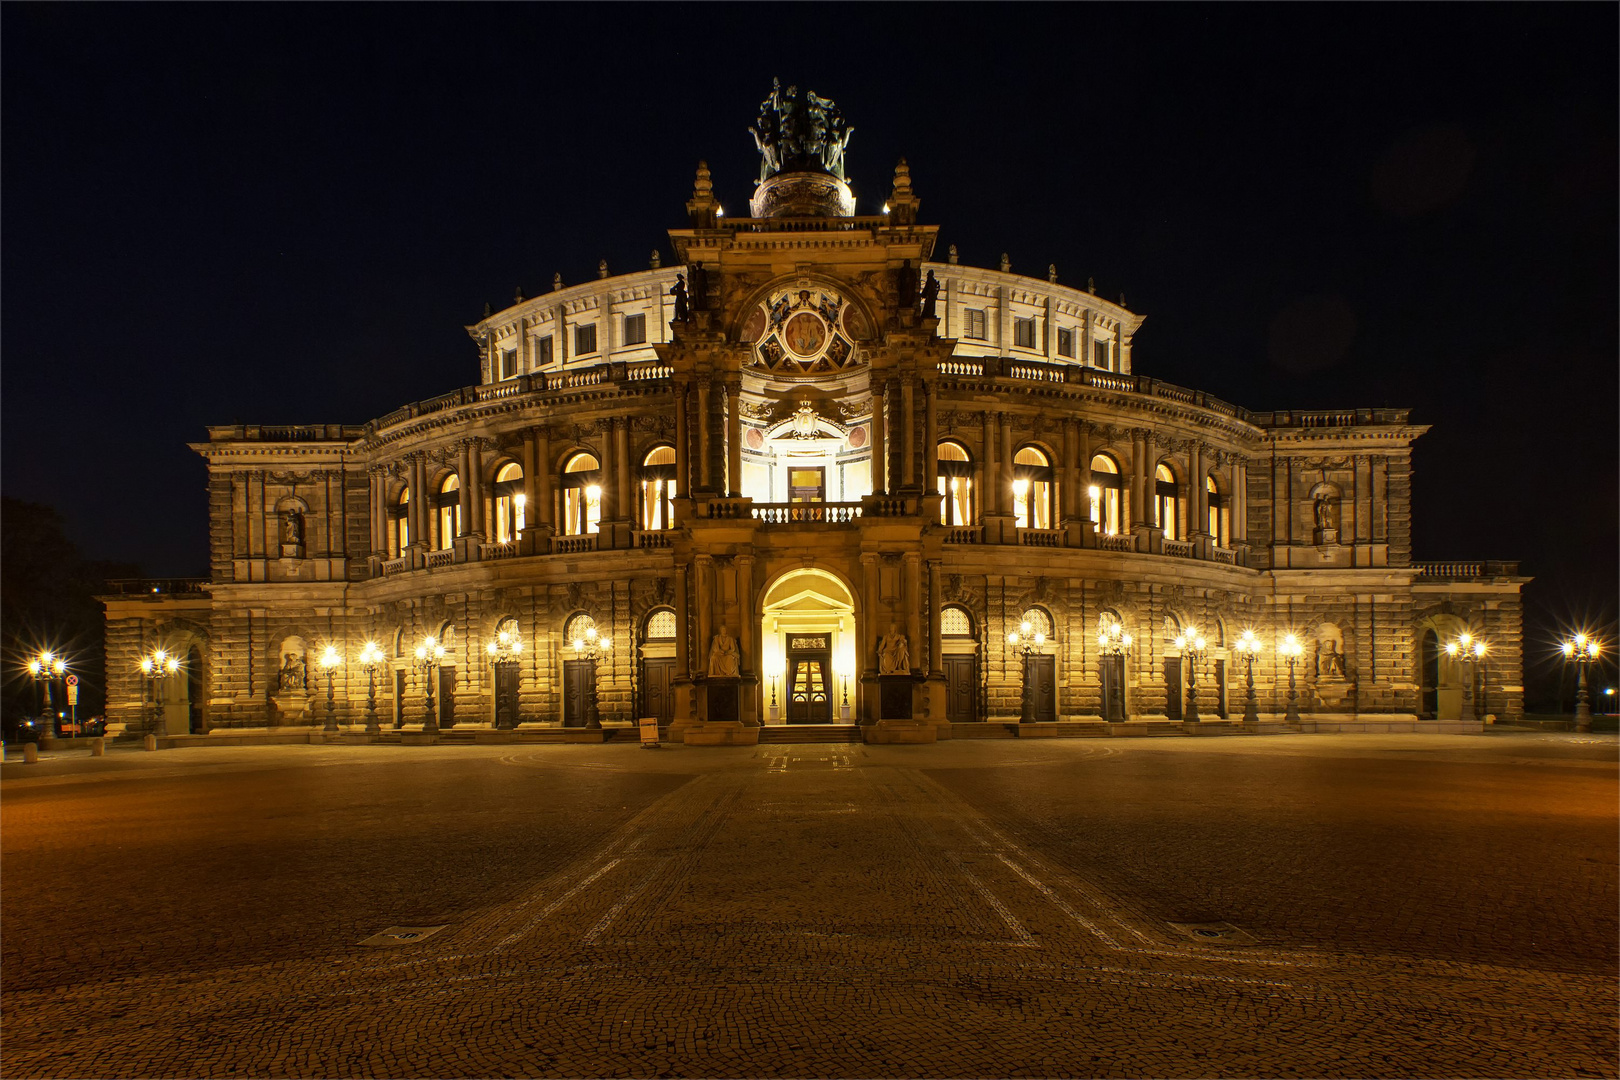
[98,97,1524,743]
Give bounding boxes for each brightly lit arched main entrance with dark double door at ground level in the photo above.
[760,568,859,724]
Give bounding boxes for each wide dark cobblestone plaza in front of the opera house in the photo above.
[0,733,1620,1077]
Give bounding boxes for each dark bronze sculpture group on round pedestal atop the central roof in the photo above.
[748,79,855,217]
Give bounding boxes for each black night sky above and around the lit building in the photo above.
[0,3,1620,702]
